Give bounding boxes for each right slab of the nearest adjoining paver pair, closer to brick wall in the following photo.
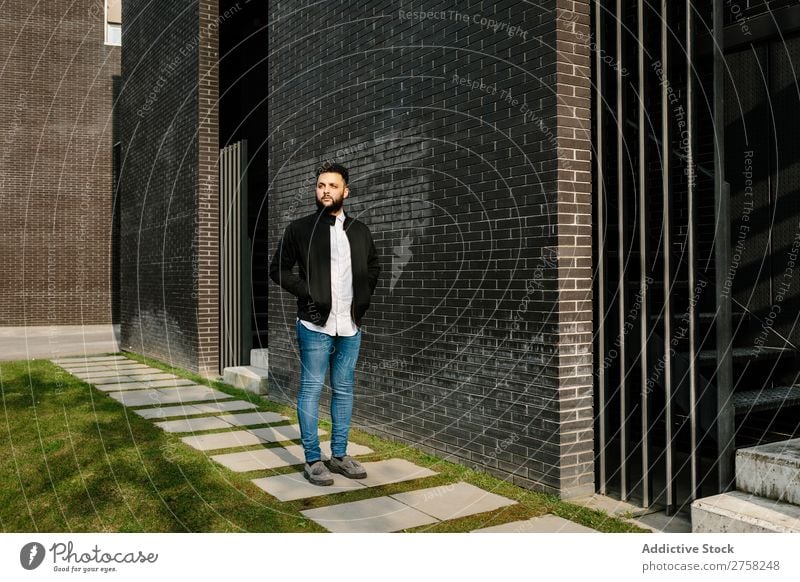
[390,481,517,520]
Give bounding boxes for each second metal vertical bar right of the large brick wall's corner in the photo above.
[616,0,628,501]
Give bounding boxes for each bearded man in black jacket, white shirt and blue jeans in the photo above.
[269,164,380,485]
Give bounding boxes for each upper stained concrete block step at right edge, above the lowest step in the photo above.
[736,438,800,506]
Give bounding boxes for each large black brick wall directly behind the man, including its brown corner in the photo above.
[268,0,593,497]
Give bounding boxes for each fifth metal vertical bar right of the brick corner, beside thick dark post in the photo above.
[686,0,699,500]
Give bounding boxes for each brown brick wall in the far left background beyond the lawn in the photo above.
[0,0,120,326]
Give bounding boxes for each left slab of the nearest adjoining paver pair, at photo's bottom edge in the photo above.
[300,497,438,533]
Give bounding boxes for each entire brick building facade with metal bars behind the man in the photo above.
[0,0,800,511]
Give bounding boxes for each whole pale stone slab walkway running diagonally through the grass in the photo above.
[52,356,595,533]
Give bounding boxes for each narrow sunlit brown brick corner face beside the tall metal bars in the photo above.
[556,0,594,498]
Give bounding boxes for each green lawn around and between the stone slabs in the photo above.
[0,354,643,532]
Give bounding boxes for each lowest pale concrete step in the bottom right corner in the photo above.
[692,491,800,533]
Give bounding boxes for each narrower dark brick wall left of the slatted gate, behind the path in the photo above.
[120,0,218,374]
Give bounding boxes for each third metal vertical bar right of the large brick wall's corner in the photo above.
[637,0,650,508]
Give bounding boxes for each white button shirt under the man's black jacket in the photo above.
[298,211,358,336]
